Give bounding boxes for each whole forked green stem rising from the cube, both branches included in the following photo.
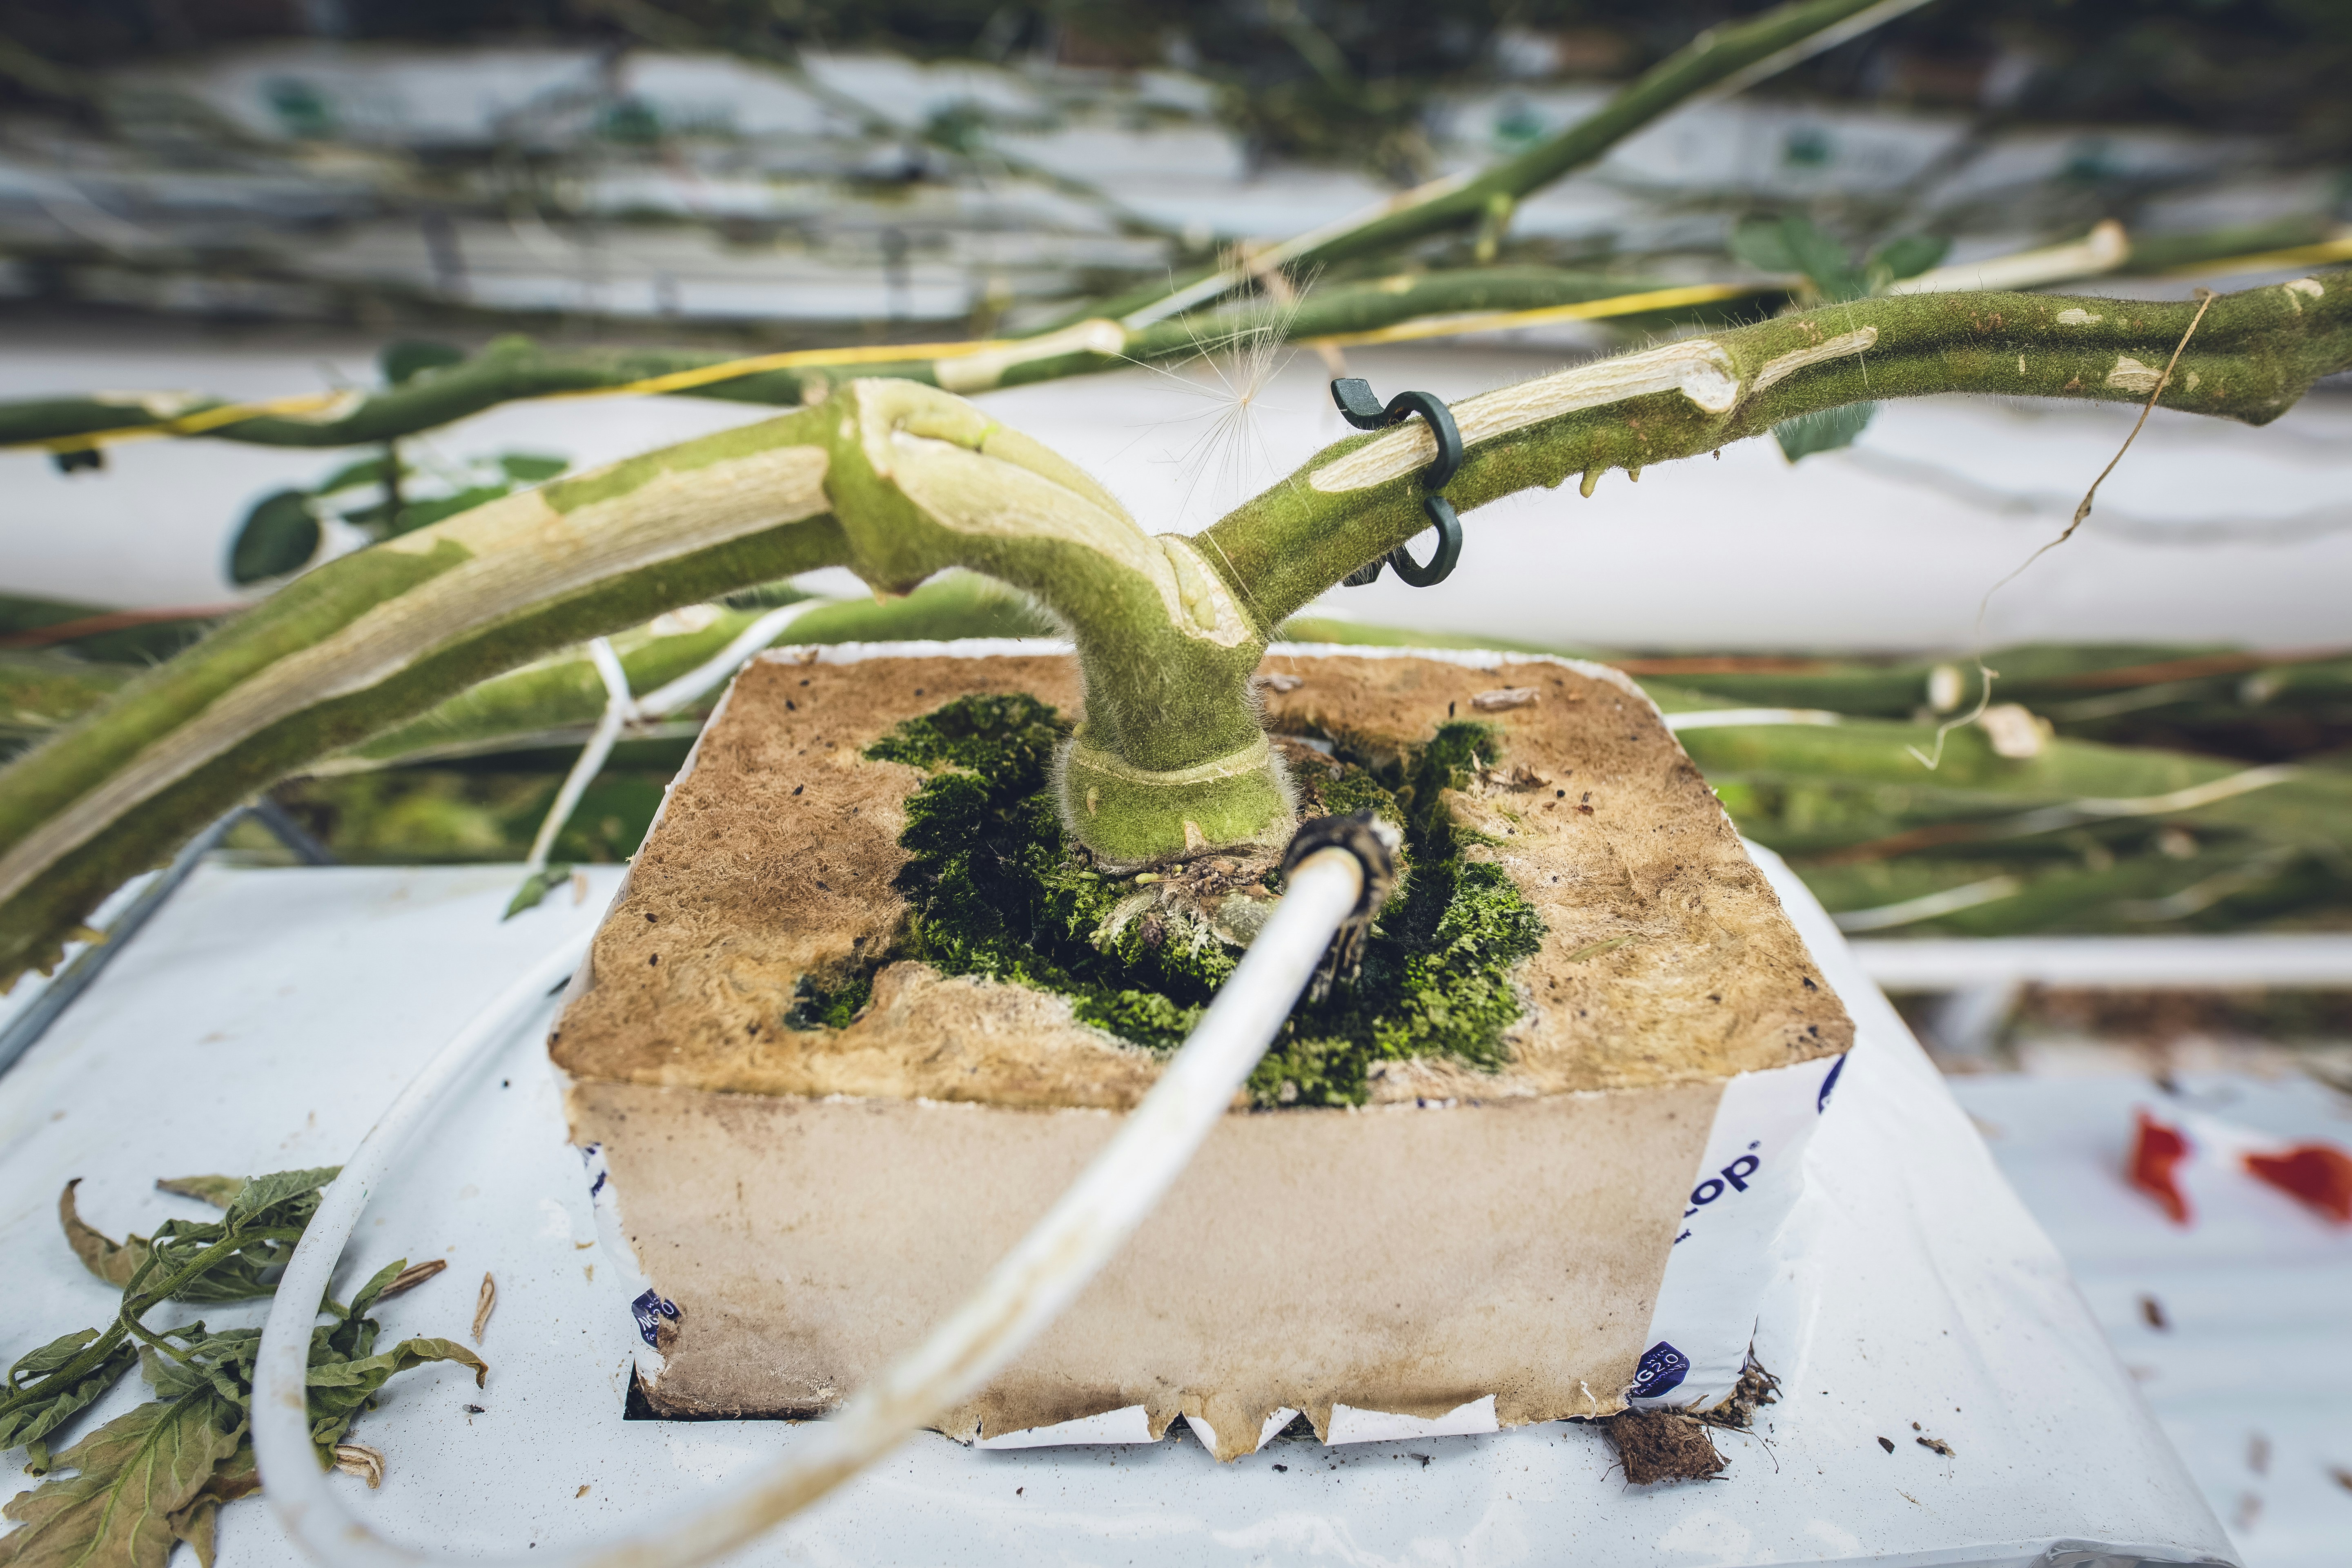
[0,273,2352,982]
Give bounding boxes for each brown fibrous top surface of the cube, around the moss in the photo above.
[553,653,1853,1109]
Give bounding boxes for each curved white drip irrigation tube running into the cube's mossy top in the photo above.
[254,846,1364,1568]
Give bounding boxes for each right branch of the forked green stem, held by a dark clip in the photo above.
[1202,273,2352,621]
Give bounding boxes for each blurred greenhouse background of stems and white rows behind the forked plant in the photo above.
[0,0,2352,1067]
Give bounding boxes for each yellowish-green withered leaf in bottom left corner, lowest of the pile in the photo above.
[0,1396,242,1568]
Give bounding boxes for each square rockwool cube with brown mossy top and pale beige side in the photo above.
[550,644,1853,1457]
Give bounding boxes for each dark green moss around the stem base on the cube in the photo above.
[842,696,1543,1105]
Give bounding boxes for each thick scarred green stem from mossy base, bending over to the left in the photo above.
[0,381,1289,982]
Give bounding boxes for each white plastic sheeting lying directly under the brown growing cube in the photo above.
[0,858,2234,1568]
